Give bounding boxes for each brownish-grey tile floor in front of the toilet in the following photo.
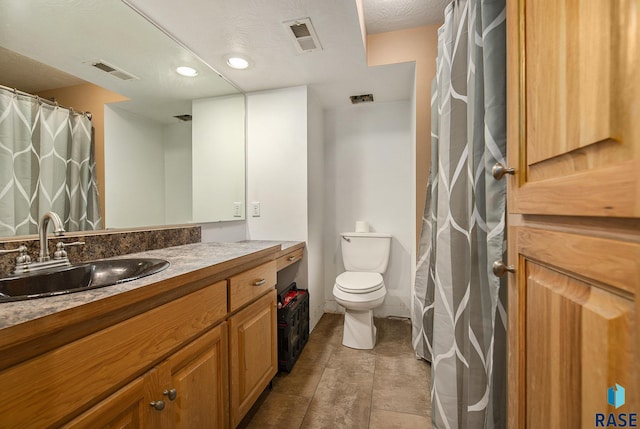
[239,313,431,429]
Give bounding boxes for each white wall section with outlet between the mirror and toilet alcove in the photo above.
[247,86,308,241]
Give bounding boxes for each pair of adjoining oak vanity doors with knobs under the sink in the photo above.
[63,322,229,429]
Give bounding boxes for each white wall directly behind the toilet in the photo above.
[324,101,415,317]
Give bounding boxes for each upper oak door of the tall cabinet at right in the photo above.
[507,0,640,218]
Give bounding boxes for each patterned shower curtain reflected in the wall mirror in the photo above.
[0,88,102,237]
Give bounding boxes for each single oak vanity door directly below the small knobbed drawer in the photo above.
[229,290,278,427]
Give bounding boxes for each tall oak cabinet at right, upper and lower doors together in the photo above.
[507,0,640,428]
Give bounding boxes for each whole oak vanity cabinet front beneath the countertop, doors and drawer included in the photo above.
[0,249,278,429]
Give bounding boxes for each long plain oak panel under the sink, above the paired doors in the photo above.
[0,281,227,429]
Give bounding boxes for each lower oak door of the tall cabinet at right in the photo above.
[509,227,640,428]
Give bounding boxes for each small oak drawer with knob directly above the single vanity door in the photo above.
[229,261,277,312]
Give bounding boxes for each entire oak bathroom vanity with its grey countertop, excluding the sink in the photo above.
[0,241,304,428]
